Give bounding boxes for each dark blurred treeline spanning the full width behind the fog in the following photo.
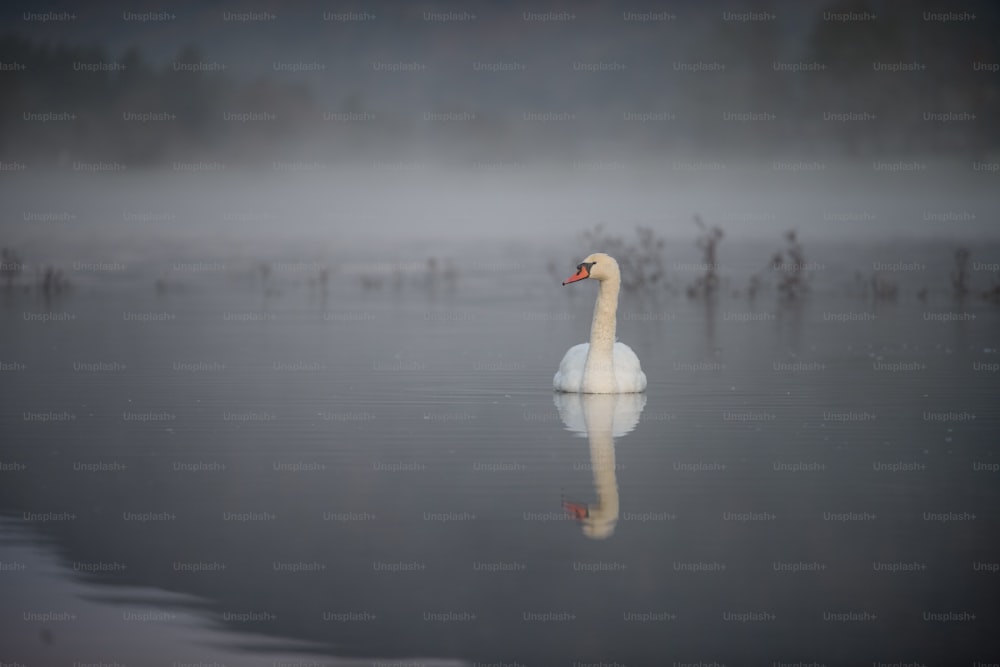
[0,0,1000,165]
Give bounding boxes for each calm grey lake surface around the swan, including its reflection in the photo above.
[0,243,1000,665]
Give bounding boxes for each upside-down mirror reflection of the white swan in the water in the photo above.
[553,393,646,540]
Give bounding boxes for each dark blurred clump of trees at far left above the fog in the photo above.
[0,35,319,164]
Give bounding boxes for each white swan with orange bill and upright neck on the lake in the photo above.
[552,252,646,394]
